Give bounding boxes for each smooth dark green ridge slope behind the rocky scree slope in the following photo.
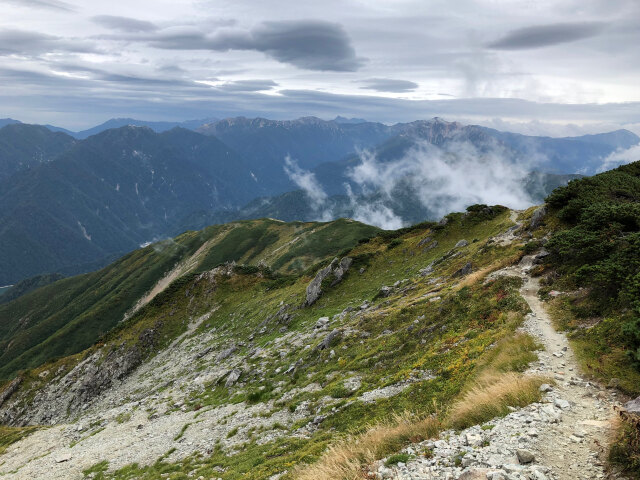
[0,219,378,379]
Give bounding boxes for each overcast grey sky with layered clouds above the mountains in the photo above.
[0,0,640,136]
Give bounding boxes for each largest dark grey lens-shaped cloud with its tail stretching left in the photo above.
[150,20,363,72]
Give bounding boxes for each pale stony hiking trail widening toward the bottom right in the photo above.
[374,251,618,480]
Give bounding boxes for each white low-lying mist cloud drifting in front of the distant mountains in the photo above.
[285,142,535,229]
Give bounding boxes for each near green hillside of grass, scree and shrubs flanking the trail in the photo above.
[0,163,640,480]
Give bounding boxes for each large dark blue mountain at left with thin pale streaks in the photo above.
[0,127,264,285]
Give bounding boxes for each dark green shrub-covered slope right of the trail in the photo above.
[524,162,640,478]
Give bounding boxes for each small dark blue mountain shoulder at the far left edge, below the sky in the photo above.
[0,123,76,183]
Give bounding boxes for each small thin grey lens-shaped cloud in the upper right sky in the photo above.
[488,22,605,50]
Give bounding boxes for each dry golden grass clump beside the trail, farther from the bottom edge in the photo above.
[448,372,549,429]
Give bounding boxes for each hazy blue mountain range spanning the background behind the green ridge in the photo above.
[0,117,640,285]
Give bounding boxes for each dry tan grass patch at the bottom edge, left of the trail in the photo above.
[295,414,442,480]
